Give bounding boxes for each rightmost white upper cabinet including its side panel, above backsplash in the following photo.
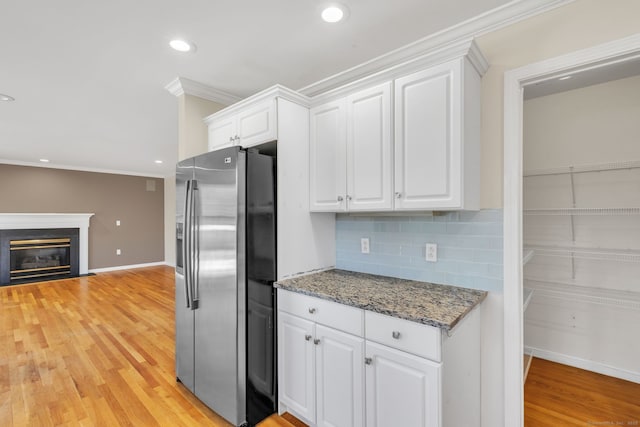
[394,58,480,210]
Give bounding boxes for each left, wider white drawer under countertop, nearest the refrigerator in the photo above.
[278,289,364,337]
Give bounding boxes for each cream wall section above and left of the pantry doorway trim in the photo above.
[477,0,640,208]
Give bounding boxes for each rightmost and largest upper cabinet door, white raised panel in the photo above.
[394,60,463,209]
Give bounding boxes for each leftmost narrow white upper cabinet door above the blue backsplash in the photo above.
[309,99,347,212]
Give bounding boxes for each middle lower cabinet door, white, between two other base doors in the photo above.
[314,325,364,427]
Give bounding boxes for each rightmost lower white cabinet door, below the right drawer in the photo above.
[365,341,441,427]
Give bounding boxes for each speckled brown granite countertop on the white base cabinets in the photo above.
[275,270,487,331]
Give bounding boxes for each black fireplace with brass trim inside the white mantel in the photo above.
[0,228,79,285]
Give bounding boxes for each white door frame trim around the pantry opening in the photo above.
[503,34,640,426]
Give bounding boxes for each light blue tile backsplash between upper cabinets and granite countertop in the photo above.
[336,209,502,292]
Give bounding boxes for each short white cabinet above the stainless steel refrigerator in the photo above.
[209,99,278,151]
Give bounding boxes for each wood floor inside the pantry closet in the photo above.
[524,357,640,427]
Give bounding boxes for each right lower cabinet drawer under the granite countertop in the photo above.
[365,311,442,362]
